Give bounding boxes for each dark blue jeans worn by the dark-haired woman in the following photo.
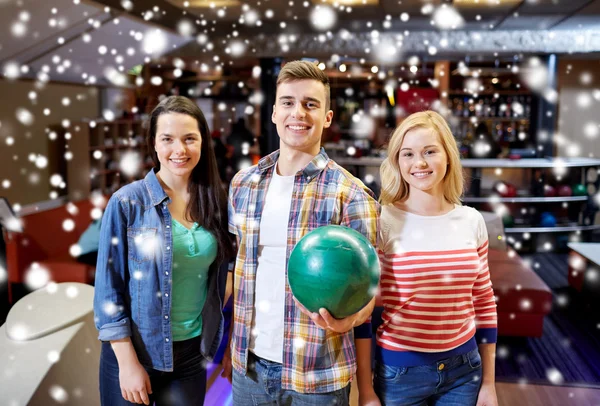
[100,337,206,406]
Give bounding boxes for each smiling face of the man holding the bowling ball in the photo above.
[271,79,333,155]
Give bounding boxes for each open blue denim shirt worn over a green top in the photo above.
[94,169,228,371]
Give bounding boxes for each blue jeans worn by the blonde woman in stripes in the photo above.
[374,348,482,406]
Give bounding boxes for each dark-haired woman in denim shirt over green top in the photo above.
[94,96,233,406]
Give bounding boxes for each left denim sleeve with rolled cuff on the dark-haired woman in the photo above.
[94,195,131,341]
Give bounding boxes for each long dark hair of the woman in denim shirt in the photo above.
[146,96,233,261]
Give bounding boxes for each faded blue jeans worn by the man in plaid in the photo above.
[232,352,350,406]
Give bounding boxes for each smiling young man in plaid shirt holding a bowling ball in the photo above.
[223,61,379,405]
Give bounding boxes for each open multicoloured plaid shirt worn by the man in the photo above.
[229,149,380,393]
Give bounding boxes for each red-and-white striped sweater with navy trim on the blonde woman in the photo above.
[376,205,497,366]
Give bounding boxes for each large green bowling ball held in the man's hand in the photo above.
[288,225,381,319]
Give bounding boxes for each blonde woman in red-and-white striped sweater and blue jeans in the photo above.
[359,111,497,406]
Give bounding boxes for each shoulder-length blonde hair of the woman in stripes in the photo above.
[379,110,464,205]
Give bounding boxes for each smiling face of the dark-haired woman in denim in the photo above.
[154,113,202,178]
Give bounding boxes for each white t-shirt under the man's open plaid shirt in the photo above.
[249,166,295,363]
